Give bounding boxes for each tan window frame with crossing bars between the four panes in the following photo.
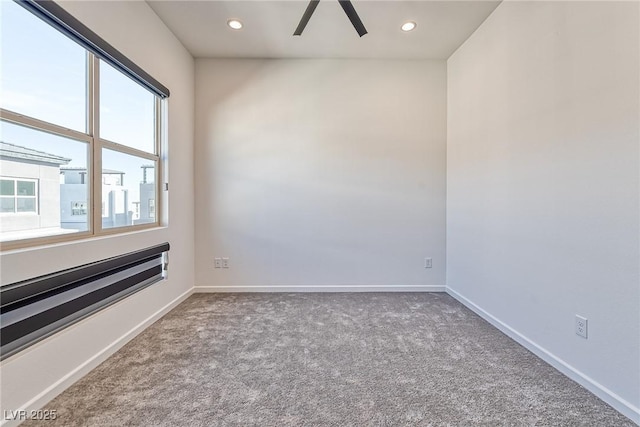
[0,44,167,252]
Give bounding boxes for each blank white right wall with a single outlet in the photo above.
[447,2,640,422]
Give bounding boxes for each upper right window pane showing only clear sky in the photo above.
[100,61,156,153]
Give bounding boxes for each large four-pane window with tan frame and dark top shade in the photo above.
[0,0,169,249]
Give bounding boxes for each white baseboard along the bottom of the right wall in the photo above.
[446,286,640,425]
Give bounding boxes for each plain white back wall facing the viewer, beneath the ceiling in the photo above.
[195,60,446,290]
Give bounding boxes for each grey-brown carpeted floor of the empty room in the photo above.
[24,293,634,427]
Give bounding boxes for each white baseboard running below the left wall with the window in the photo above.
[0,288,193,427]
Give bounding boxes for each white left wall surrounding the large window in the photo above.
[0,2,194,422]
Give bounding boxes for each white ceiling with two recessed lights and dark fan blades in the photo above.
[147,0,500,59]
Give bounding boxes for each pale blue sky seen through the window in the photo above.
[0,0,155,196]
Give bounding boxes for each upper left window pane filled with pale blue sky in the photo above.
[0,1,86,132]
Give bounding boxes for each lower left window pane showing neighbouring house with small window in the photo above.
[0,120,89,241]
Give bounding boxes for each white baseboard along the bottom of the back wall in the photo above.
[194,285,446,293]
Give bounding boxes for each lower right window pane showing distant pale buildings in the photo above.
[102,149,156,228]
